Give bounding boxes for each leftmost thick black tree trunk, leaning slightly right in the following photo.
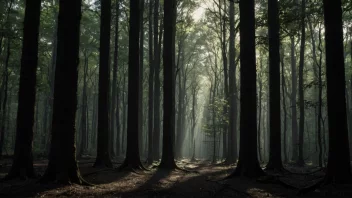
[7,0,41,178]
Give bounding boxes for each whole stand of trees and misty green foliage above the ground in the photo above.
[0,0,352,196]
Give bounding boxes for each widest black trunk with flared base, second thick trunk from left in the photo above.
[42,0,84,184]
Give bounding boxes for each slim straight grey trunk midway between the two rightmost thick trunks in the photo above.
[297,0,306,166]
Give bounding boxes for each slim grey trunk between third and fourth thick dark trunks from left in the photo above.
[109,0,120,157]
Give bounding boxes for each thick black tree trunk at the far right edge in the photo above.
[323,0,352,184]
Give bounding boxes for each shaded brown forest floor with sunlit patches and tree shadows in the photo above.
[0,158,352,197]
